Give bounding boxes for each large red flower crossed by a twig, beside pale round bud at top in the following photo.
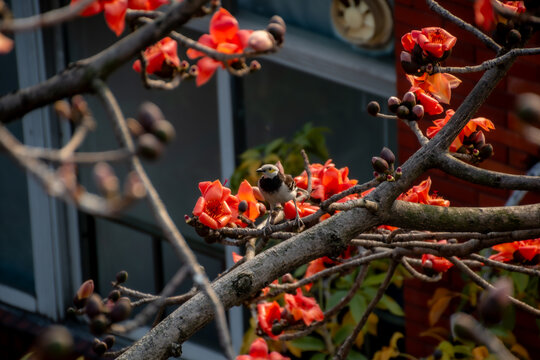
[187,8,252,86]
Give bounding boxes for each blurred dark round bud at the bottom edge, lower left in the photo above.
[31,325,74,360]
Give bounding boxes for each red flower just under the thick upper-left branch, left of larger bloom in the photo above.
[133,37,180,74]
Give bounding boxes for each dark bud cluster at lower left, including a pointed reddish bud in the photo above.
[68,271,132,342]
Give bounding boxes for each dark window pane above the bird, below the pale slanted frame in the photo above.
[241,61,396,181]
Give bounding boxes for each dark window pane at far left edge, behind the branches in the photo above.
[0,38,35,294]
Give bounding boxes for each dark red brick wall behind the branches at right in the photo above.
[394,0,540,358]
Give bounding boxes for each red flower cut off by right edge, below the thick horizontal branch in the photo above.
[489,238,540,265]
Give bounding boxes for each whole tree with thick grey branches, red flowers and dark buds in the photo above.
[0,0,540,359]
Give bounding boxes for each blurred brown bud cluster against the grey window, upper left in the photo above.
[127,102,176,160]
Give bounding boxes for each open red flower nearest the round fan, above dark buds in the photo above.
[401,27,457,58]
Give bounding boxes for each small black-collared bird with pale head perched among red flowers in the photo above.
[257,164,302,227]
